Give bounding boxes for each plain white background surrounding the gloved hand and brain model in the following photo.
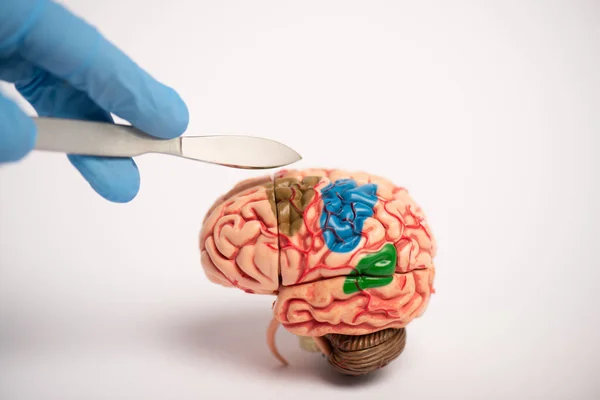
[0,0,600,400]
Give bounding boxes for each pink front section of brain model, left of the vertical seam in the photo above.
[200,177,279,294]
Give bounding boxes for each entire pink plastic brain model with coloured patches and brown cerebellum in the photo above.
[200,169,436,375]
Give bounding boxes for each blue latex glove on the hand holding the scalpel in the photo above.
[0,0,189,202]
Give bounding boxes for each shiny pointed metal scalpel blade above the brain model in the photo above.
[181,136,302,169]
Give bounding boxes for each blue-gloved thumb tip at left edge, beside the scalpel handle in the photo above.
[0,93,37,163]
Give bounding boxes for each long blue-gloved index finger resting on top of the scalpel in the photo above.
[0,0,189,139]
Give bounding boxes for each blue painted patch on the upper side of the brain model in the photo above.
[320,179,378,253]
